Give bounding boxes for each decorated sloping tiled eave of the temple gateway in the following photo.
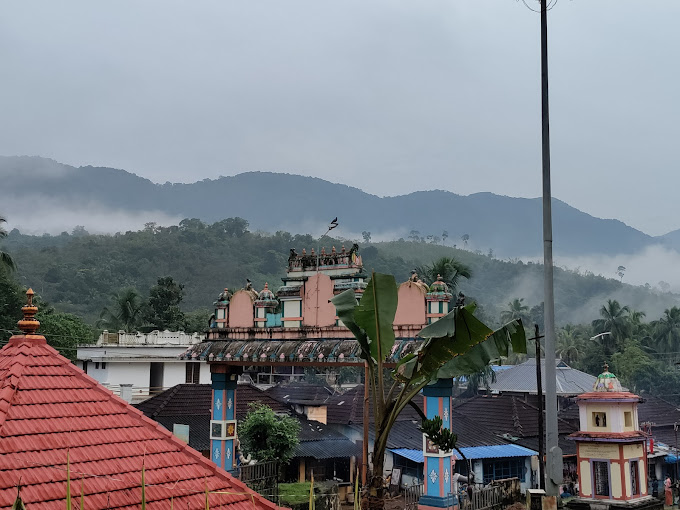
[180,339,422,366]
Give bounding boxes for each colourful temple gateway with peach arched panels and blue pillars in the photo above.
[182,244,455,498]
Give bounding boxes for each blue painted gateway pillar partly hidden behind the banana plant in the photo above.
[418,379,458,510]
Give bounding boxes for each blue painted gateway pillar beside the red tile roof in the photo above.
[210,373,238,471]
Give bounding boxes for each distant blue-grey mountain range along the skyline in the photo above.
[0,157,668,257]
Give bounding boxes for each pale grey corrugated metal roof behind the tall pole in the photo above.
[489,358,597,397]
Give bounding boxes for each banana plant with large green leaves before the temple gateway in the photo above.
[331,272,526,510]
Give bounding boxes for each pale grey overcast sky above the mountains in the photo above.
[0,0,680,234]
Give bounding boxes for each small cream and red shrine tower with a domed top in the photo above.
[569,364,659,508]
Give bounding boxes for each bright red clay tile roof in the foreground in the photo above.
[0,335,276,510]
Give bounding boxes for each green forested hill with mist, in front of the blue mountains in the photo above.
[2,219,678,323]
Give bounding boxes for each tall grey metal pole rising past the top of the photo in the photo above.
[540,0,562,496]
